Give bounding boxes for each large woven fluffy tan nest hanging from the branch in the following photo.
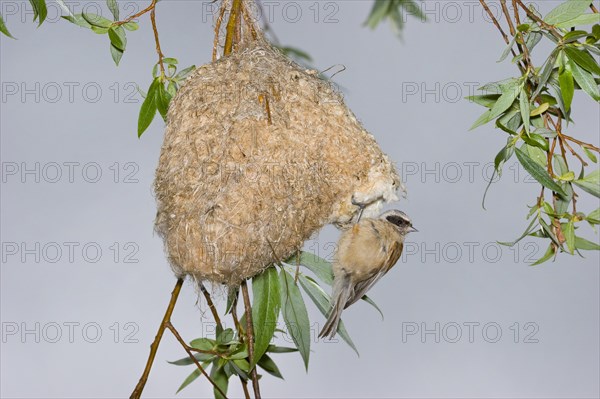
[155,40,401,286]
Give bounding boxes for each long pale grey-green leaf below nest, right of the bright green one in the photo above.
[278,269,310,370]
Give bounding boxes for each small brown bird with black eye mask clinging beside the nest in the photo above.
[319,209,418,338]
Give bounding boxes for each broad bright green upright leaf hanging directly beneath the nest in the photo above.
[251,267,281,367]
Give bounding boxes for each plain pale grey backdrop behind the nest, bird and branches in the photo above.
[0,1,599,398]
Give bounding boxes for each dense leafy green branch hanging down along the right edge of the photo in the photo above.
[469,0,600,264]
